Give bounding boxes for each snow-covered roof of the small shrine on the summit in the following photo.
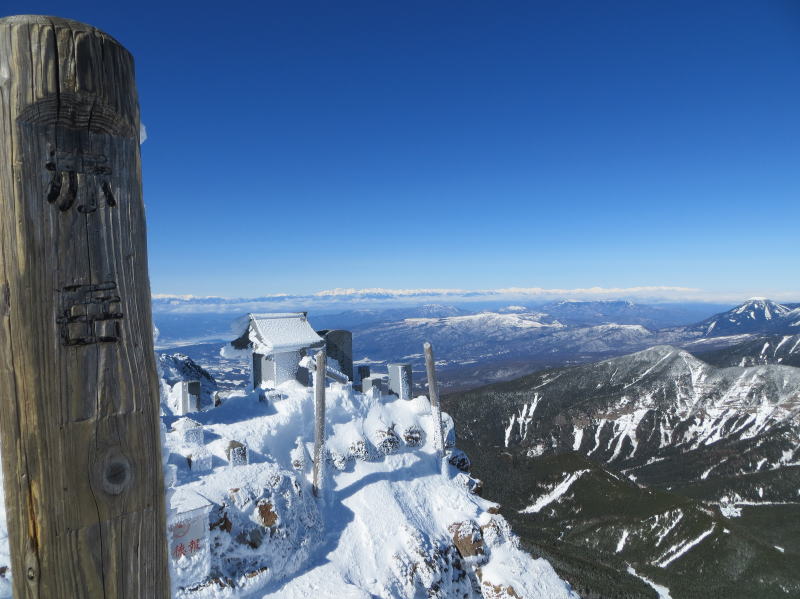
[244,312,325,355]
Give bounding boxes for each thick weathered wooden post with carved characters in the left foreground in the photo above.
[0,16,169,599]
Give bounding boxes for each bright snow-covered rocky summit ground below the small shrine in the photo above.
[165,372,576,599]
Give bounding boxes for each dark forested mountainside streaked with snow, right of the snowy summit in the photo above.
[445,344,800,598]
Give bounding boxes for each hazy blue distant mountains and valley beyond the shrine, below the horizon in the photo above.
[155,299,800,391]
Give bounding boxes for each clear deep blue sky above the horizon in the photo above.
[2,0,800,296]
